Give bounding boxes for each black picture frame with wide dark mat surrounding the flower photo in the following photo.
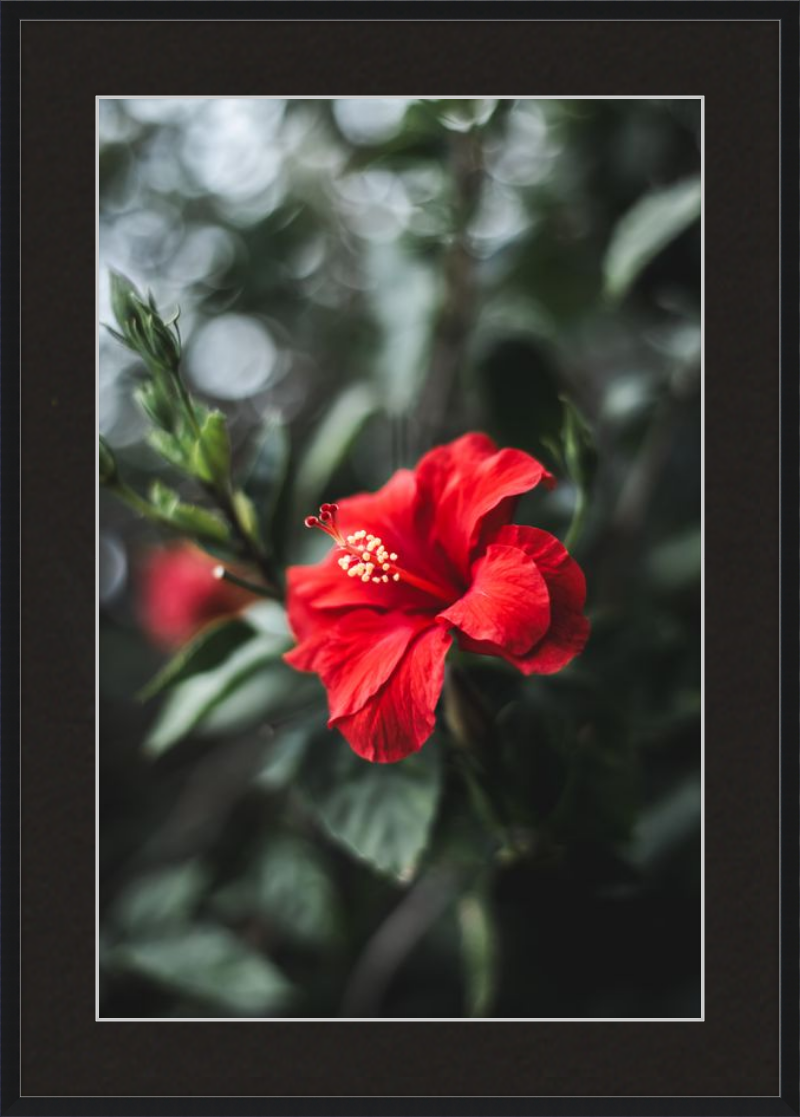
[0,0,800,1115]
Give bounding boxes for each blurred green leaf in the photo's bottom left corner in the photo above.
[109,924,292,1014]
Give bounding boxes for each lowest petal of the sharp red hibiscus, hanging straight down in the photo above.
[330,622,453,764]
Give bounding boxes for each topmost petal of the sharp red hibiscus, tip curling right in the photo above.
[417,435,555,574]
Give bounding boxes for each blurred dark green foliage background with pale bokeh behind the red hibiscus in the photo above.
[98,98,702,1018]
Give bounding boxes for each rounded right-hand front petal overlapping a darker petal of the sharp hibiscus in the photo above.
[439,544,550,655]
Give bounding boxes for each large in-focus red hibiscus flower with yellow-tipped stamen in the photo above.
[286,435,589,763]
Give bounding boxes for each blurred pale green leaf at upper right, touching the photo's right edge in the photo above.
[603,178,702,298]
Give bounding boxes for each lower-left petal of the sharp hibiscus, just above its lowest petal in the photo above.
[284,609,431,718]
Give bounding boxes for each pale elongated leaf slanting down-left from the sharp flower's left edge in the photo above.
[144,637,282,756]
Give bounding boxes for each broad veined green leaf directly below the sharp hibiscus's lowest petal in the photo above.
[301,734,441,879]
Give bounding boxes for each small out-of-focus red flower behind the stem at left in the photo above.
[139,543,255,651]
